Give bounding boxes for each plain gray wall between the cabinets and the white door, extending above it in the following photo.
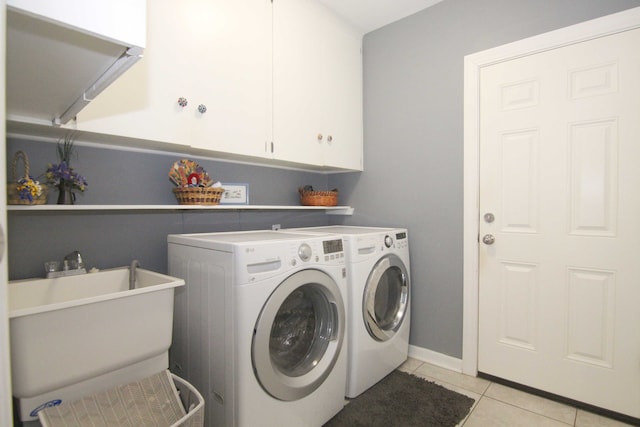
[329,0,640,358]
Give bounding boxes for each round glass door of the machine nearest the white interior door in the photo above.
[362,254,409,341]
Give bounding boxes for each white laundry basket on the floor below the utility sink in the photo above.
[38,370,204,427]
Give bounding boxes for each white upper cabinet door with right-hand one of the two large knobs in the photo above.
[191,0,271,157]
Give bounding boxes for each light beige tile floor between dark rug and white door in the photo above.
[399,358,630,427]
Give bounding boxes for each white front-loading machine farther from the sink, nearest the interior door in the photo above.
[283,226,410,398]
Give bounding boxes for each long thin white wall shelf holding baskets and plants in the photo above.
[7,204,353,215]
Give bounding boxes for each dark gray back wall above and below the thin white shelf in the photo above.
[7,139,328,280]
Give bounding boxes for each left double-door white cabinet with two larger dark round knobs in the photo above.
[77,0,271,157]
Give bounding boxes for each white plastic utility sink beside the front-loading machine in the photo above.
[8,267,184,421]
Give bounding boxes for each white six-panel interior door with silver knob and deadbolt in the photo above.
[478,26,640,417]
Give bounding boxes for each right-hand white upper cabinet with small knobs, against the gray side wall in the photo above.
[273,0,363,170]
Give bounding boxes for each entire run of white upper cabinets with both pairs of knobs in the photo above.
[76,0,362,170]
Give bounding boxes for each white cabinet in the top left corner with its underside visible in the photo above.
[6,0,146,126]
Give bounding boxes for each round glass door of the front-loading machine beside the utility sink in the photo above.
[251,269,345,401]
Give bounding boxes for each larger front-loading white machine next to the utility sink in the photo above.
[168,231,347,427]
